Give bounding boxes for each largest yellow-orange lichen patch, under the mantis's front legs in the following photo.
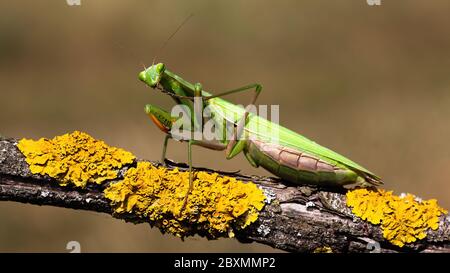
[105,162,265,238]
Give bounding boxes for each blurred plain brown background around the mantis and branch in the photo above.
[0,0,450,252]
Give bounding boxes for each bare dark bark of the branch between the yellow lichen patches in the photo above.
[0,135,450,252]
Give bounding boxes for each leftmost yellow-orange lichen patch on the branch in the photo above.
[17,131,135,188]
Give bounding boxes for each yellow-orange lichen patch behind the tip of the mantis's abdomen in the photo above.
[347,189,447,247]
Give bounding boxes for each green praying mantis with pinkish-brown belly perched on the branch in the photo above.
[139,63,382,209]
